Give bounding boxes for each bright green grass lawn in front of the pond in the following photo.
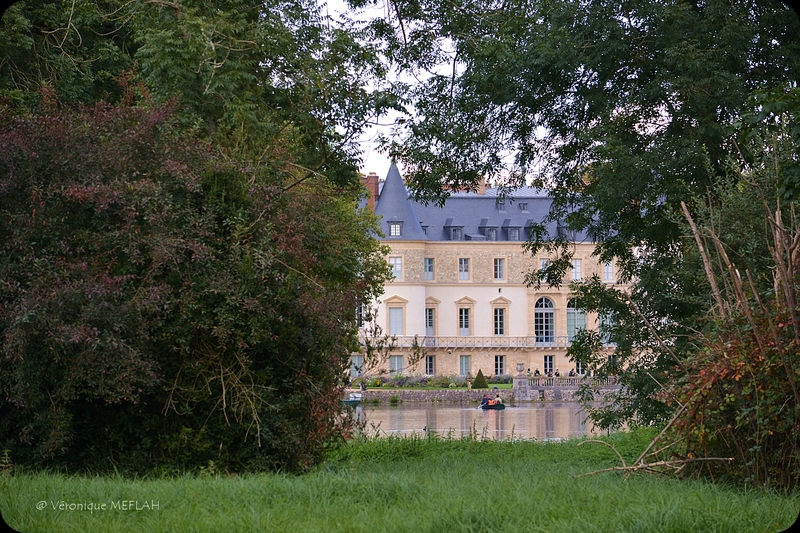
[0,432,800,533]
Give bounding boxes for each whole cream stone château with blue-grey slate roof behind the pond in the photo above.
[353,166,616,377]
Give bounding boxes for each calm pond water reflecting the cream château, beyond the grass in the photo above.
[356,402,601,440]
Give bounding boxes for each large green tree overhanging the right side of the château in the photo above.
[351,0,800,426]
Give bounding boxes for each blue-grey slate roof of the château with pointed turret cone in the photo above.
[375,163,589,241]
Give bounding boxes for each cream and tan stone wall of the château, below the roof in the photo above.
[360,240,620,376]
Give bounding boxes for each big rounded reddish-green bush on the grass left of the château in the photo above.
[0,100,386,470]
